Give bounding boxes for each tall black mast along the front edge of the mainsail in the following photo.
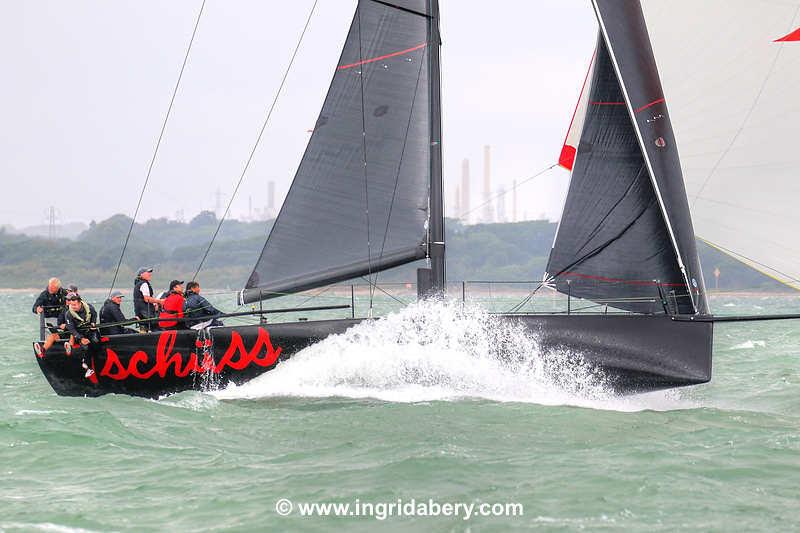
[428,0,447,294]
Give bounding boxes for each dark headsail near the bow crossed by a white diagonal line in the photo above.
[546,0,708,314]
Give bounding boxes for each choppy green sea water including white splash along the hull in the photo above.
[0,293,800,531]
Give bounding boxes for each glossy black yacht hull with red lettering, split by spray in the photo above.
[36,315,713,398]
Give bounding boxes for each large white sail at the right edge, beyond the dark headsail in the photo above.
[642,0,800,289]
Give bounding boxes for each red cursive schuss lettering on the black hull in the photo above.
[100,328,282,381]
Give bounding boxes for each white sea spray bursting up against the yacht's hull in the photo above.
[215,301,611,404]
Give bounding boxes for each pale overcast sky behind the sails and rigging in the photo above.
[0,0,597,227]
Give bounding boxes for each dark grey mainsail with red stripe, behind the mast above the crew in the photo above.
[240,0,441,303]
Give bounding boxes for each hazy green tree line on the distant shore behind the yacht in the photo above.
[0,211,784,291]
